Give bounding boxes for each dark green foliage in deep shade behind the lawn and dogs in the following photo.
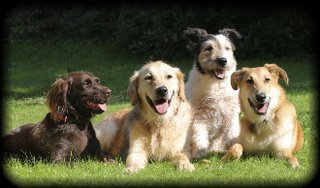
[5,3,316,60]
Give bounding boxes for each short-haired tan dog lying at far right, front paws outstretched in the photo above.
[222,64,304,168]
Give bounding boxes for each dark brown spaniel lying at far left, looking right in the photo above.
[3,72,111,162]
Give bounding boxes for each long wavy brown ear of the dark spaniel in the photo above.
[47,78,69,122]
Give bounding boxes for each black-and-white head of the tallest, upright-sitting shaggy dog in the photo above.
[184,28,241,80]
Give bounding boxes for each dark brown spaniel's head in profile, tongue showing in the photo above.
[47,72,111,122]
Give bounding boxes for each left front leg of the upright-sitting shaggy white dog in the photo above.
[192,123,209,158]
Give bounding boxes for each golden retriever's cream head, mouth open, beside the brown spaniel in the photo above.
[128,61,186,115]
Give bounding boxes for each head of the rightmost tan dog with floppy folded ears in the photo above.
[231,64,289,115]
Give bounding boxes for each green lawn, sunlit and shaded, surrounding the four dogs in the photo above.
[3,42,318,186]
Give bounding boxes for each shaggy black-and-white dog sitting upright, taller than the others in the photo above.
[183,28,241,157]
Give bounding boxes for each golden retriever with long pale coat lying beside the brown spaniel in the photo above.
[95,61,195,173]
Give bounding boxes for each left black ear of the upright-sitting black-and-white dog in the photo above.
[183,27,208,53]
